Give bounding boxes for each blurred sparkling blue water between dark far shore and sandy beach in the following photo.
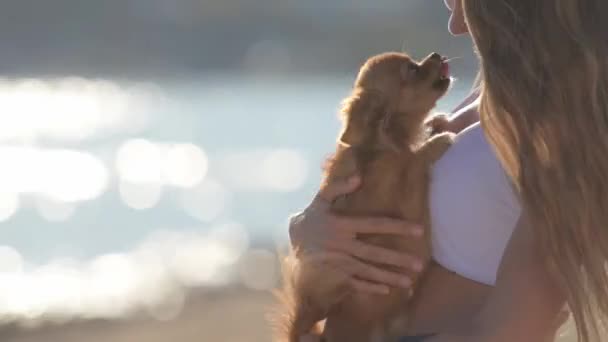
[0,74,470,318]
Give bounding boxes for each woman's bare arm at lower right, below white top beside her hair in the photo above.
[429,214,567,342]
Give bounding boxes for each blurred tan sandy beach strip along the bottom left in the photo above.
[0,288,575,342]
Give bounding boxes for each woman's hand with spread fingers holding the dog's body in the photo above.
[289,177,423,294]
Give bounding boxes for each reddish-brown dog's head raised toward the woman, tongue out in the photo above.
[340,53,451,149]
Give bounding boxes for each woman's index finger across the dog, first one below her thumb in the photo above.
[332,216,424,237]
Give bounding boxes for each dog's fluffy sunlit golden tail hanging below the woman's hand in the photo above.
[271,251,325,342]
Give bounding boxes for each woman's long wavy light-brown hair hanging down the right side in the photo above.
[463,0,608,342]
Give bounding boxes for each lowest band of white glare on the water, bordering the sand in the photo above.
[0,227,252,320]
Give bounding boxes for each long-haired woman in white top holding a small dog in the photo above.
[290,0,608,342]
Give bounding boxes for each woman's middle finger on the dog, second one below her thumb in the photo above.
[328,240,423,272]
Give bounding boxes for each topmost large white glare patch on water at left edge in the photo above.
[0,77,147,142]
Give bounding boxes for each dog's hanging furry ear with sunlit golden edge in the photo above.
[338,89,385,146]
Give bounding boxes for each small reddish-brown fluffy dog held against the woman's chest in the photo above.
[275,53,453,342]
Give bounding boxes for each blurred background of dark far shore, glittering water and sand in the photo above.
[0,0,568,342]
